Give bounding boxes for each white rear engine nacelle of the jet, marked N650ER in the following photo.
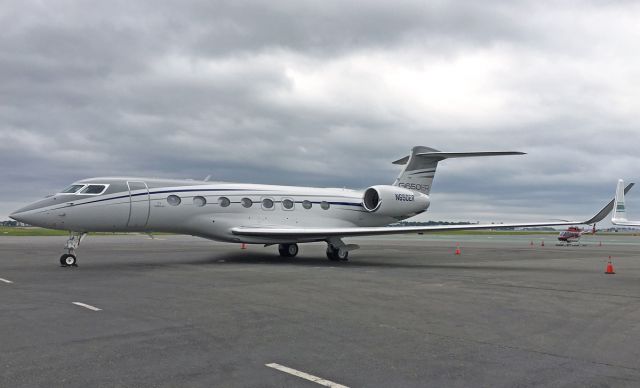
[362,186,430,218]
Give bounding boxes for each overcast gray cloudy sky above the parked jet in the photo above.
[0,0,640,221]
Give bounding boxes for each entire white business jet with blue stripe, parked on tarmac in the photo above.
[10,147,633,266]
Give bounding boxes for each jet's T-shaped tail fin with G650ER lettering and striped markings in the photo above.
[393,146,525,195]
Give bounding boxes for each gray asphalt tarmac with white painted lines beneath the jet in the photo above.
[0,235,640,387]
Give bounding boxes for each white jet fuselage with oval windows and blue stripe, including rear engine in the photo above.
[11,178,429,244]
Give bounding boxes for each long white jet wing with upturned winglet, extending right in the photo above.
[231,183,634,239]
